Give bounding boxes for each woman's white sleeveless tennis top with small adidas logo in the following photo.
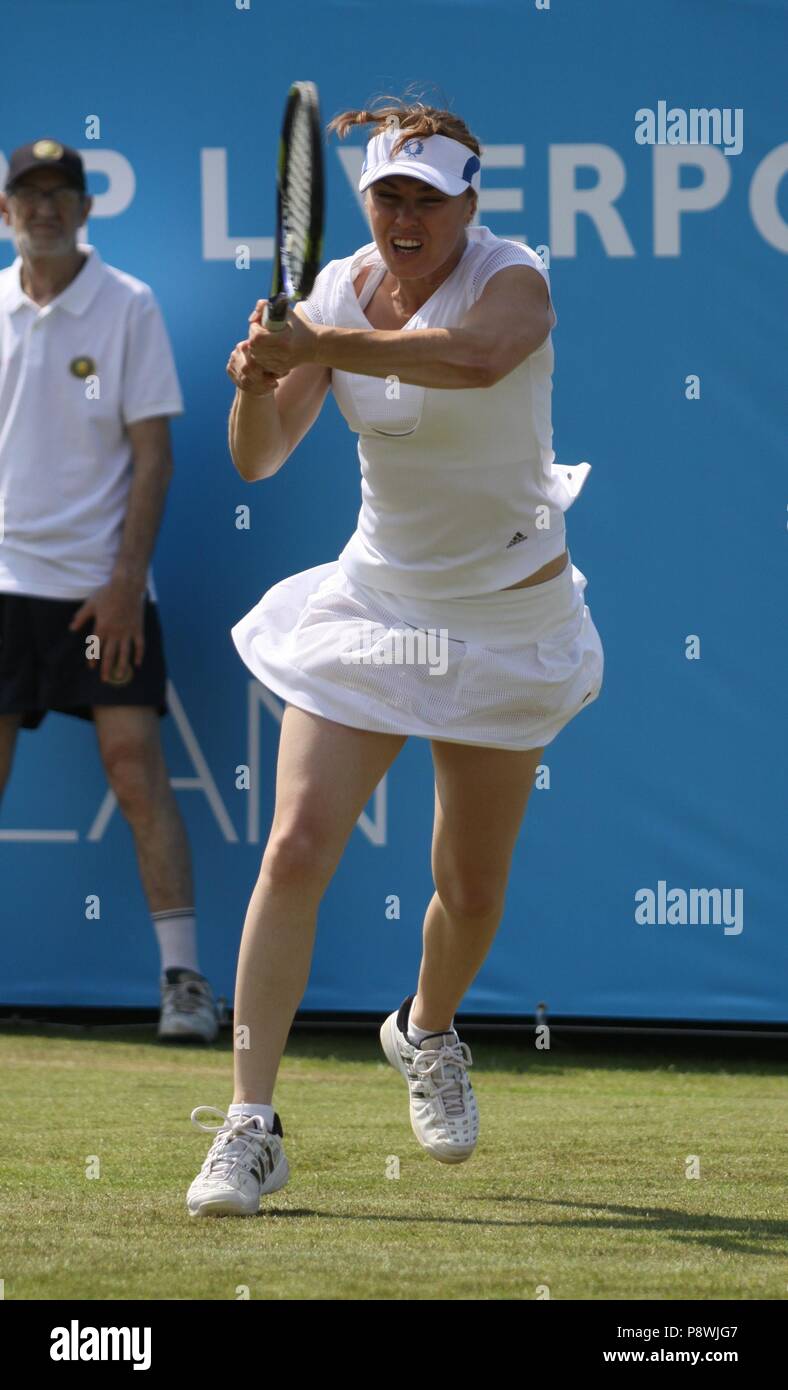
[303,227,591,598]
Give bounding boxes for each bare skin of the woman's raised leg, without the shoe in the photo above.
[411,741,543,1031]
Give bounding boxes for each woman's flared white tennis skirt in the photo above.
[231,555,605,751]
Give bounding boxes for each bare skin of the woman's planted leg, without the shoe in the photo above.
[233,705,406,1105]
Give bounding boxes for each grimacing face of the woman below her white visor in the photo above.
[367,174,475,279]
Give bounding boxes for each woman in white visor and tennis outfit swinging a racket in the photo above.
[188,101,603,1216]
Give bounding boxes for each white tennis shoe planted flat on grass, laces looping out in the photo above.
[186,1105,290,1216]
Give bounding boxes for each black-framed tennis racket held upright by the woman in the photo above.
[263,82,324,332]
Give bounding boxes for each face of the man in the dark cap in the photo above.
[4,170,92,257]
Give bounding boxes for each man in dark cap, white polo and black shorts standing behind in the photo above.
[0,139,218,1043]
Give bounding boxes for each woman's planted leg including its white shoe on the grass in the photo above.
[186,705,406,1216]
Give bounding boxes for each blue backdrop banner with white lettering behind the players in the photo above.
[0,0,788,1020]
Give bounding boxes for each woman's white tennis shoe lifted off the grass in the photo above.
[381,994,479,1163]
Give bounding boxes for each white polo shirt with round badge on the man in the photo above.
[0,242,183,599]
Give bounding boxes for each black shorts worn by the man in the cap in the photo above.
[0,594,167,728]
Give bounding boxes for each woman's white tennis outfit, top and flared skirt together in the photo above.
[232,227,605,751]
